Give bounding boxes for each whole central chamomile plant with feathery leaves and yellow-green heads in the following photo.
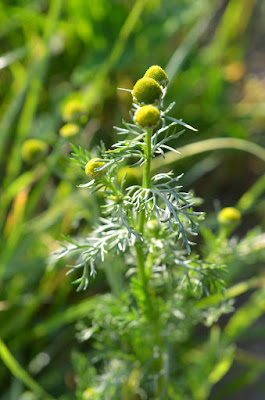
[56,66,226,400]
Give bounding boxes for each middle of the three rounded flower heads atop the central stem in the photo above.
[132,78,163,106]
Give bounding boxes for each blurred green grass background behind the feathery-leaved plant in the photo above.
[0,0,265,400]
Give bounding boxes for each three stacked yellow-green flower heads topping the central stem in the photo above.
[132,65,168,129]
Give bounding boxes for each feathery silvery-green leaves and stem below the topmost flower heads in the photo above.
[55,60,263,400]
